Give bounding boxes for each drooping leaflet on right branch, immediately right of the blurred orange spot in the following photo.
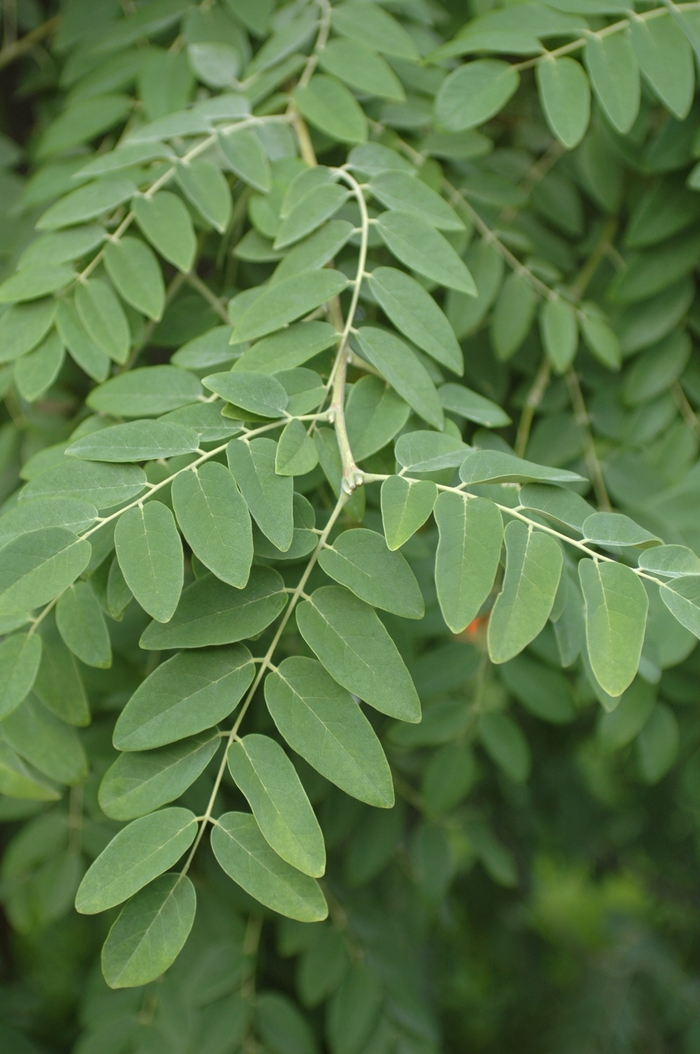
[488,520,564,663]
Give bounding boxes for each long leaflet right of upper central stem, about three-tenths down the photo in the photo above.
[369,267,464,374]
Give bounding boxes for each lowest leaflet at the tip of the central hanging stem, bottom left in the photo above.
[101,874,197,989]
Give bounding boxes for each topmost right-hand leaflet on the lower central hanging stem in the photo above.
[318,528,425,619]
